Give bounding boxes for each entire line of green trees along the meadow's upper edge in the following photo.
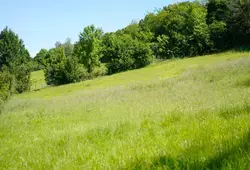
[0,0,250,110]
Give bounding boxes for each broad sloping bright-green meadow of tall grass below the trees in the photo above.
[0,52,250,169]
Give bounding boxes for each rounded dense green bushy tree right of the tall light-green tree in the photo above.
[103,34,153,74]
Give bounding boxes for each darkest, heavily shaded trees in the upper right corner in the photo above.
[206,0,250,50]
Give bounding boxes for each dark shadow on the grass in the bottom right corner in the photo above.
[129,131,250,170]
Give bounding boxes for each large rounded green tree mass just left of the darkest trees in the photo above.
[155,2,211,58]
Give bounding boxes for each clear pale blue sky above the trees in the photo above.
[0,0,175,57]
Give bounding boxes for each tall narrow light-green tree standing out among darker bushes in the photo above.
[74,25,103,73]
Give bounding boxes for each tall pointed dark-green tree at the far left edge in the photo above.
[0,27,31,111]
